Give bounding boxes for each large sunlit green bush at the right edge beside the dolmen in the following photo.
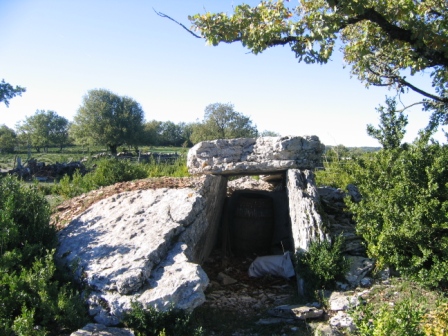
[348,144,448,287]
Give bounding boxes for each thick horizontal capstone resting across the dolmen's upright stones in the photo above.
[187,135,325,175]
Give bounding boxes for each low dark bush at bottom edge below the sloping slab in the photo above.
[123,302,203,336]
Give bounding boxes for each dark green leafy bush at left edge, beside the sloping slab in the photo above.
[0,177,88,335]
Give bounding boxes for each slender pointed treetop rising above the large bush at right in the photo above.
[367,98,408,149]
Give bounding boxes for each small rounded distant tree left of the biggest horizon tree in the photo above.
[17,110,69,152]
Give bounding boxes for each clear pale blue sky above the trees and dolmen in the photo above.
[0,0,445,146]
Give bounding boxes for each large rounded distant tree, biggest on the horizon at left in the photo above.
[70,89,144,155]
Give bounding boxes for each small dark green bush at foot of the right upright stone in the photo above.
[296,236,349,295]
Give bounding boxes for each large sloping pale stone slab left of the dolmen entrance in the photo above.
[56,176,227,326]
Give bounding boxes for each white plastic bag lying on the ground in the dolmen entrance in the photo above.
[249,252,295,279]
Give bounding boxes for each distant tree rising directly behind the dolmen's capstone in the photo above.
[191,103,258,143]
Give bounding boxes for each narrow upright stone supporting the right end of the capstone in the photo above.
[286,169,329,251]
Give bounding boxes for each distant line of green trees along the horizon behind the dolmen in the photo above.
[0,89,279,154]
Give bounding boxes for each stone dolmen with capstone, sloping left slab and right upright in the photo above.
[56,136,328,326]
